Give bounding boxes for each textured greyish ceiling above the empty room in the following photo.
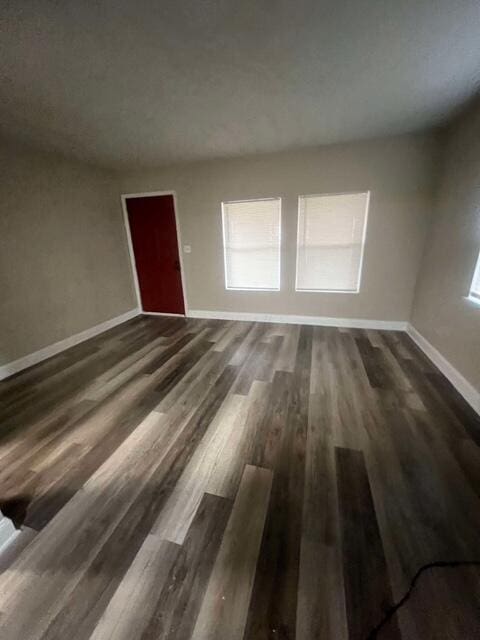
[0,0,480,166]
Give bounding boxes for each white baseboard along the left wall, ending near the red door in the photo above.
[0,309,141,380]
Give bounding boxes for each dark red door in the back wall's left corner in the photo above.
[127,195,185,315]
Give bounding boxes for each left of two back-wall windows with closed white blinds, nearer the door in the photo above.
[222,198,281,291]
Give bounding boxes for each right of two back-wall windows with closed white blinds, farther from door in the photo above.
[296,192,369,293]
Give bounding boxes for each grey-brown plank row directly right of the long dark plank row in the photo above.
[295,327,348,640]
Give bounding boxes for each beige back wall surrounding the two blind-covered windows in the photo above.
[121,136,435,320]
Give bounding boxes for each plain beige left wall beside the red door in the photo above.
[0,142,136,364]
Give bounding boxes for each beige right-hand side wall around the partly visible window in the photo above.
[412,105,480,391]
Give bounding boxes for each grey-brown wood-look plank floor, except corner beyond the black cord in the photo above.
[0,317,480,640]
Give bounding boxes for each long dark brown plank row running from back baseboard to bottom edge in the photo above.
[246,327,313,638]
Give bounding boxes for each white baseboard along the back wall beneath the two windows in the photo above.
[188,309,408,331]
